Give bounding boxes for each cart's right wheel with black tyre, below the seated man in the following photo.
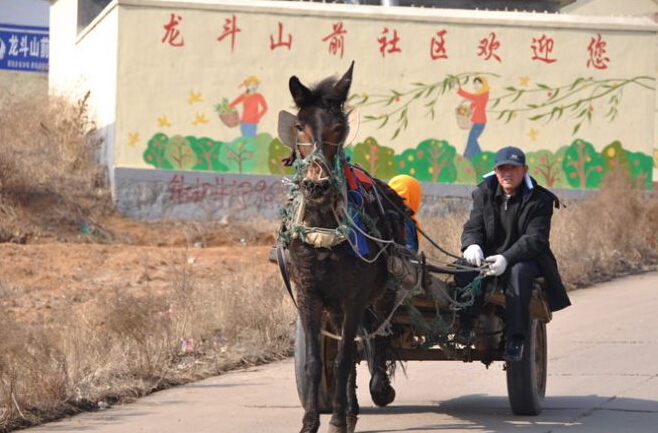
[507,319,547,415]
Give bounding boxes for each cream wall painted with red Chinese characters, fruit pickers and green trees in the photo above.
[48,0,657,188]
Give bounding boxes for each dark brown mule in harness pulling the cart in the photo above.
[282,62,405,433]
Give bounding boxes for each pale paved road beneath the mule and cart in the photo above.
[32,273,658,433]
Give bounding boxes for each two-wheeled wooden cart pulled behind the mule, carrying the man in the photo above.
[280,250,552,415]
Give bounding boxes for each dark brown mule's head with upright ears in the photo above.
[289,62,354,199]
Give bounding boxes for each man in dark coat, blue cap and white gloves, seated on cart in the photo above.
[454,147,571,361]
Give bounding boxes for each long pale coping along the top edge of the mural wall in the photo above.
[114,0,658,33]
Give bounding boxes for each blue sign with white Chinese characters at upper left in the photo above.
[0,24,49,73]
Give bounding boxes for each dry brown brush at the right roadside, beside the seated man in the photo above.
[551,172,658,288]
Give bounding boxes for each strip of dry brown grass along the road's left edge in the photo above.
[0,257,294,432]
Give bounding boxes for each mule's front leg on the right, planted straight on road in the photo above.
[329,306,363,433]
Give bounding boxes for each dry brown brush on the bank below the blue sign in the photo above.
[0,91,111,242]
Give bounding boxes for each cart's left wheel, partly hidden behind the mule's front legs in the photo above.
[295,317,338,413]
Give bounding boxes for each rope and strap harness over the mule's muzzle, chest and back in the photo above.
[277,138,487,340]
